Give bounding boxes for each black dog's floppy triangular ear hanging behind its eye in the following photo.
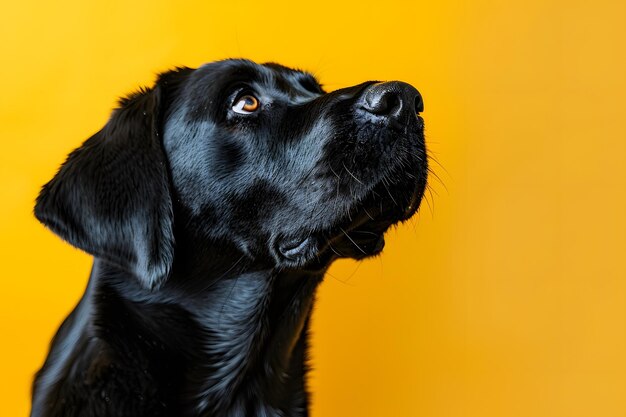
[35,86,174,288]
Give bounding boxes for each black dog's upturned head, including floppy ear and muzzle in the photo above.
[35,60,427,287]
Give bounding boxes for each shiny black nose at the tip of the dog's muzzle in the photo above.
[360,81,424,119]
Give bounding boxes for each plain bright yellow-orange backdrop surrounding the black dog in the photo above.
[0,0,626,417]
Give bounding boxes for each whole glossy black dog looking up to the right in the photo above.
[32,60,427,417]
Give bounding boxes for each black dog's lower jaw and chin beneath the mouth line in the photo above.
[274,185,423,270]
